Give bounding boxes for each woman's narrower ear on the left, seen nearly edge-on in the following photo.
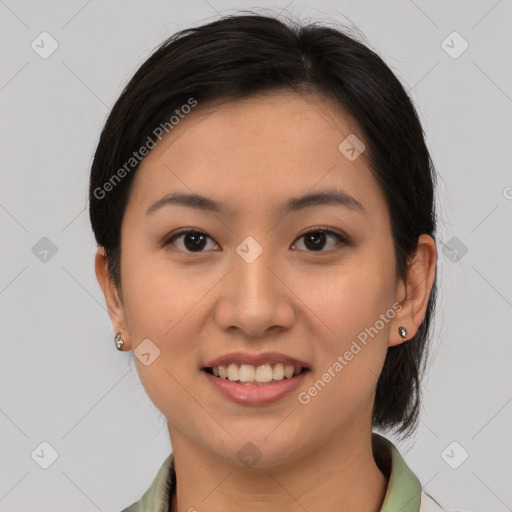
[94,246,130,350]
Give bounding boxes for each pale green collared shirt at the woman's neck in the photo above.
[122,433,445,512]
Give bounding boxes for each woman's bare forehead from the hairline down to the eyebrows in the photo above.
[126,91,382,219]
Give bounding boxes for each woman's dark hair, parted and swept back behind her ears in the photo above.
[89,13,437,437]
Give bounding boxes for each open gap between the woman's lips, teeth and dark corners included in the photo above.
[202,363,310,386]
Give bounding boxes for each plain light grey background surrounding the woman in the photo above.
[0,0,512,512]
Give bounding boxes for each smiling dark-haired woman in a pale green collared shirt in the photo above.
[90,14,448,512]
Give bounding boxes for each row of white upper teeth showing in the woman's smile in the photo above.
[213,363,302,382]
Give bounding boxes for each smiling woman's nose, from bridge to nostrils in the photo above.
[215,245,295,337]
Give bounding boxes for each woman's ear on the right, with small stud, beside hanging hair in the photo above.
[388,235,437,347]
